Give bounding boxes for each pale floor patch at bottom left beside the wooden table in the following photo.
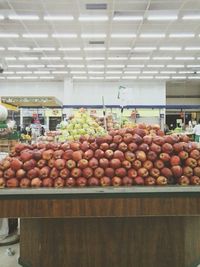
[0,243,21,267]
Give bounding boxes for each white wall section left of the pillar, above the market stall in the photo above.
[0,81,64,102]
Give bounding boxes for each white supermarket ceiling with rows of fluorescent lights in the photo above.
[0,0,200,81]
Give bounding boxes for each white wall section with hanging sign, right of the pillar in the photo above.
[64,81,166,105]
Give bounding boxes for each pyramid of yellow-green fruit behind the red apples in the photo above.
[59,109,105,142]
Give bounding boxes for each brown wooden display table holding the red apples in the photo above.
[0,187,200,267]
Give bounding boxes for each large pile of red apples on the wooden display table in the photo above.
[0,128,200,188]
